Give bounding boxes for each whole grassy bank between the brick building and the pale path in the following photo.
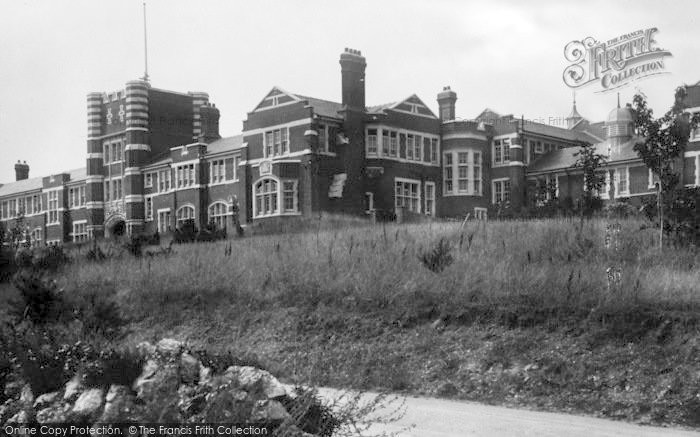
[1,220,700,426]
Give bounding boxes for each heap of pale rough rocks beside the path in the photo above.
[0,339,313,437]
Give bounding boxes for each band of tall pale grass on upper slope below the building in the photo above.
[63,219,700,334]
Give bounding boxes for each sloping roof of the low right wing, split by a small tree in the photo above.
[527,138,639,173]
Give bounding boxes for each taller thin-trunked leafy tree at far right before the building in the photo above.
[632,86,700,248]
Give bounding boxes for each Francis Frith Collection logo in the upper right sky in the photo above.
[564,27,672,92]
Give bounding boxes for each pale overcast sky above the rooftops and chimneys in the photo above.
[0,0,700,183]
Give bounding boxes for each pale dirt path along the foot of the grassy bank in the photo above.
[320,389,700,437]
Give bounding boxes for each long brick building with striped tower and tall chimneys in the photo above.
[0,49,700,244]
